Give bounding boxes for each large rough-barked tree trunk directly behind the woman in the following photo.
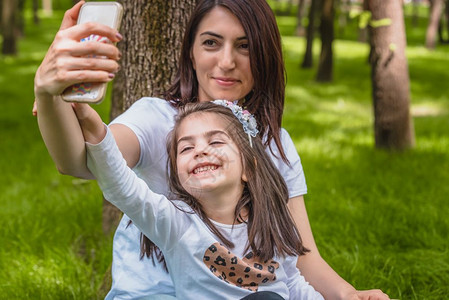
[103,0,196,233]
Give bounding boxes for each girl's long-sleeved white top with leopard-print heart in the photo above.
[87,130,323,300]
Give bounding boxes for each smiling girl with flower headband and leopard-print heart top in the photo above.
[77,100,323,299]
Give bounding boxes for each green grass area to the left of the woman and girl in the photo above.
[0,12,112,299]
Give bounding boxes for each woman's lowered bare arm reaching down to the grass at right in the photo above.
[288,196,389,300]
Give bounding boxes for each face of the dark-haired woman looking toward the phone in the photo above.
[191,6,254,102]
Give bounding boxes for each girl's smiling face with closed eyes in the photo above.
[176,112,246,201]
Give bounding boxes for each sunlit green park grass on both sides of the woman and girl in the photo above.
[0,0,449,299]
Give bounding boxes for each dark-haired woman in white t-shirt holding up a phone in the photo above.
[35,0,388,299]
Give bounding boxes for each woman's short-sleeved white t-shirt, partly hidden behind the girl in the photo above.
[106,98,307,300]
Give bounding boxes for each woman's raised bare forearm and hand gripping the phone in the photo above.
[34,1,120,178]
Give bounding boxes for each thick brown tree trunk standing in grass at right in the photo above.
[367,0,414,150]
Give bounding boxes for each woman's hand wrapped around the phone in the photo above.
[34,1,121,99]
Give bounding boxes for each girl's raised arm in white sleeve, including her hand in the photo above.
[84,122,180,251]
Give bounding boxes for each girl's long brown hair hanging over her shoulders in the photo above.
[167,102,308,261]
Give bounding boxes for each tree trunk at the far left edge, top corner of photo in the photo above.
[1,0,18,55]
